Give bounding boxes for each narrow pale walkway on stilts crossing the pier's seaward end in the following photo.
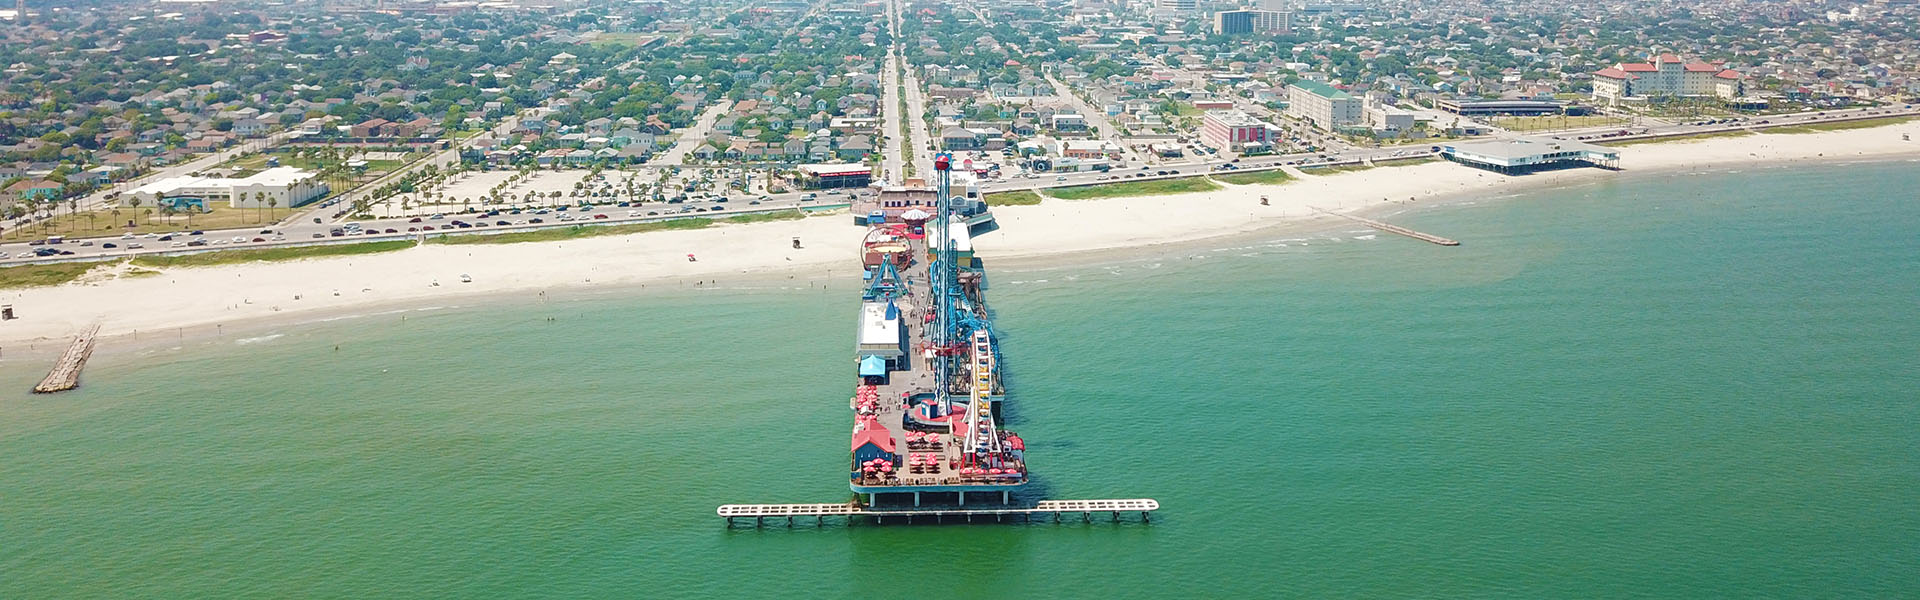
[716,498,1160,527]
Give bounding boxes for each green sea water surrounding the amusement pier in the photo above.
[0,163,1920,598]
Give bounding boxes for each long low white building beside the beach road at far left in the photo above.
[119,167,326,210]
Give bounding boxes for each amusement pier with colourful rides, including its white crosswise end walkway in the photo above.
[716,154,1160,525]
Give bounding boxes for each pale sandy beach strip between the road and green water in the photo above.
[0,121,1920,346]
